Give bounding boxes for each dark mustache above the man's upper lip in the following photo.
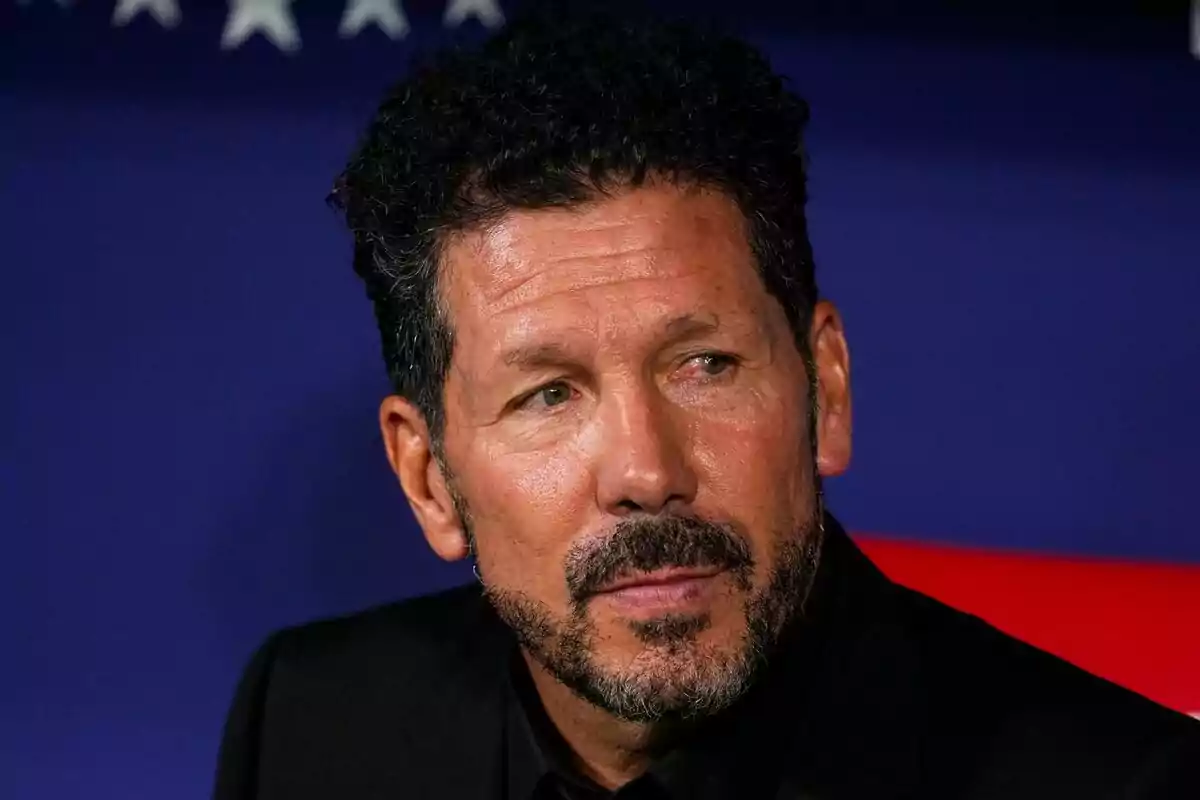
[566,517,754,606]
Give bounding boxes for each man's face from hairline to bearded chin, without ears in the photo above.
[400,184,840,721]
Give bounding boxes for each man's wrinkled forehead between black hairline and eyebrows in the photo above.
[443,185,766,345]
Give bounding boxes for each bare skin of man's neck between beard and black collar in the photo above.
[521,649,681,789]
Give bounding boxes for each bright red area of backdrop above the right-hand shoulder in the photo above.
[854,535,1200,714]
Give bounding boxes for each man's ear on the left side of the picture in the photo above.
[379,395,468,561]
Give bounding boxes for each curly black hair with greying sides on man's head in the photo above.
[330,3,817,449]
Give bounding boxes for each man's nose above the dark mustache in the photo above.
[596,383,697,516]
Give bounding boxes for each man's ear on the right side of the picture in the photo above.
[809,301,852,476]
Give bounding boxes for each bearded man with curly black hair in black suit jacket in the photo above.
[216,6,1200,800]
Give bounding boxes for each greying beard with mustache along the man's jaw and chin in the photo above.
[460,506,823,723]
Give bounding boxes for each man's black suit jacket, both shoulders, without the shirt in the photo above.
[215,521,1200,800]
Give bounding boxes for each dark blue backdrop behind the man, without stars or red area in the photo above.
[0,0,1200,800]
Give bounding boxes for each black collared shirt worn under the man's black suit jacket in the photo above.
[505,604,817,800]
